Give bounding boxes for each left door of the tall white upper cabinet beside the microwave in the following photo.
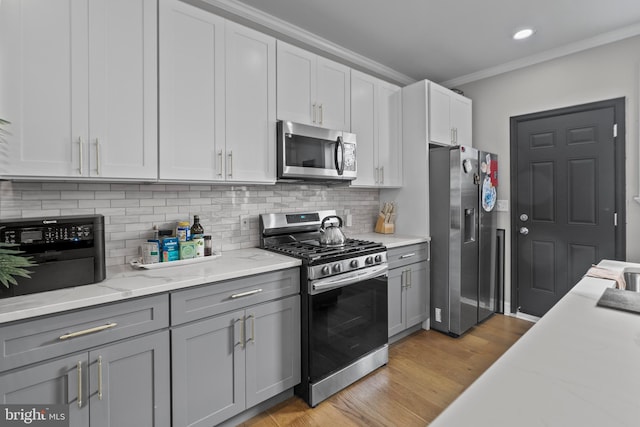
[159,0,225,181]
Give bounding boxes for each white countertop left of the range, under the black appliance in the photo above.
[0,248,301,324]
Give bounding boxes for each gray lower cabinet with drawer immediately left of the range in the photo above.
[171,269,300,427]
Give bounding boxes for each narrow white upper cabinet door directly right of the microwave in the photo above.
[351,70,378,187]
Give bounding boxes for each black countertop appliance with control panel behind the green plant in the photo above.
[0,215,106,298]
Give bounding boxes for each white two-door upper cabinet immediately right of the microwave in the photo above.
[351,70,402,187]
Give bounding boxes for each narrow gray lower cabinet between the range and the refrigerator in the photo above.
[387,243,430,337]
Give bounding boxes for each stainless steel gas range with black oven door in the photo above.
[260,210,389,407]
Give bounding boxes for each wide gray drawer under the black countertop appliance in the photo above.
[0,295,169,372]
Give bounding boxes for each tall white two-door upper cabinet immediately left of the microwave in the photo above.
[160,0,276,182]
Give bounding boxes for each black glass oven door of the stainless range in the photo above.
[308,266,388,383]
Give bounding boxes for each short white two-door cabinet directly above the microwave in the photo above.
[277,40,351,132]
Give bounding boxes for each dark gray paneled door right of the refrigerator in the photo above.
[511,99,624,316]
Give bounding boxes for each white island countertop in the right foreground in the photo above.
[430,260,640,427]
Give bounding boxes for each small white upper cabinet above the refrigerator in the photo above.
[429,82,472,146]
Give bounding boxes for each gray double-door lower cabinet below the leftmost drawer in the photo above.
[0,331,170,427]
